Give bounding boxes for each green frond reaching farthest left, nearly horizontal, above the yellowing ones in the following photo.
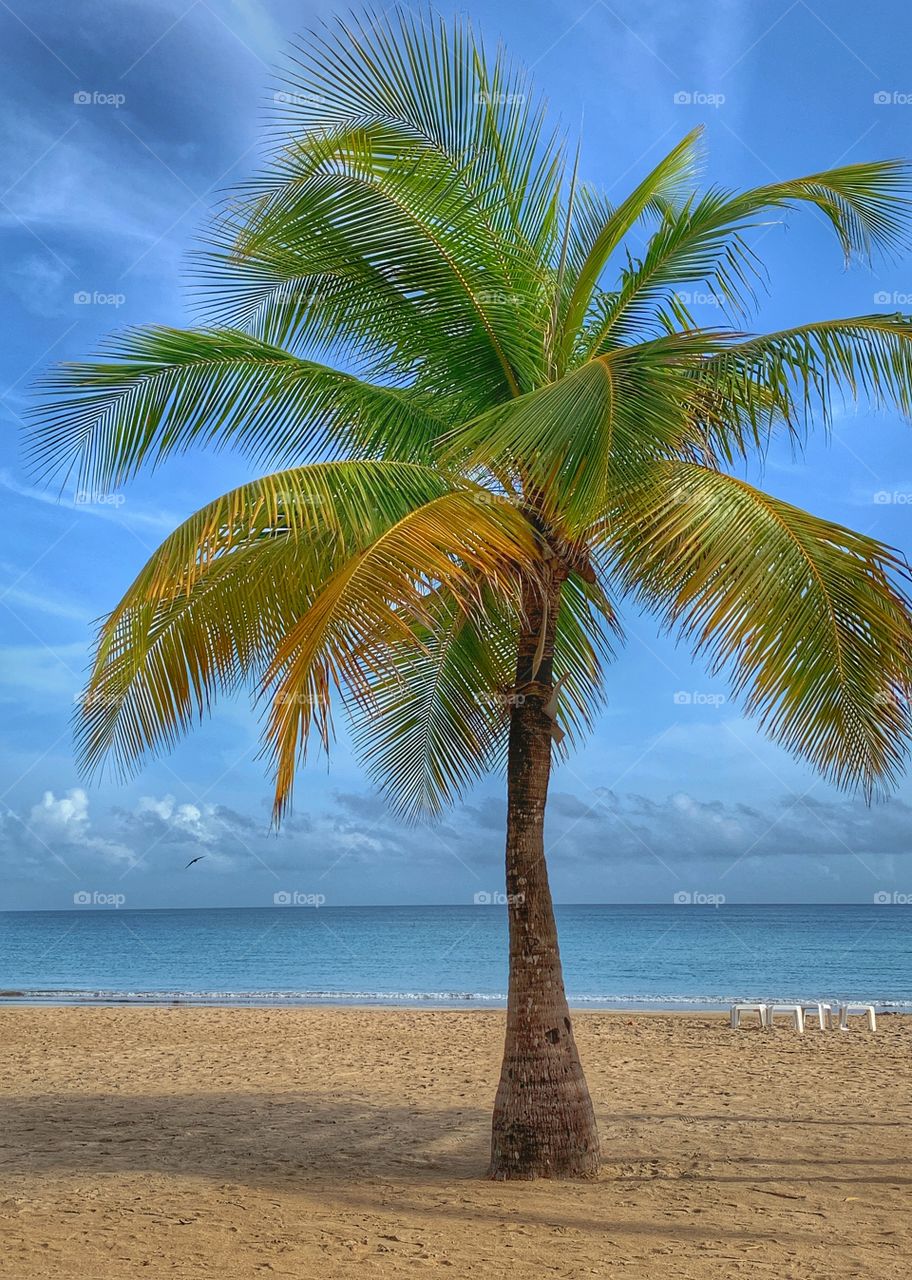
[29,328,447,492]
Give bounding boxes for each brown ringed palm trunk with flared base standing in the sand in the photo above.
[489,575,598,1179]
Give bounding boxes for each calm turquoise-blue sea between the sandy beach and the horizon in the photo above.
[0,905,912,1012]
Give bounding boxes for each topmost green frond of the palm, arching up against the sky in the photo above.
[277,9,562,250]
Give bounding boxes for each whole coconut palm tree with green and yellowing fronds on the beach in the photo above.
[33,13,912,1178]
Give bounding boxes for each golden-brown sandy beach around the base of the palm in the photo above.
[0,1007,912,1280]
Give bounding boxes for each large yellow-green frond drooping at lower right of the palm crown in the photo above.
[607,462,912,792]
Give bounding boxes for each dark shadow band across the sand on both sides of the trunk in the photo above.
[3,1092,912,1187]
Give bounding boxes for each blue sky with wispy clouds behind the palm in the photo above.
[0,0,912,908]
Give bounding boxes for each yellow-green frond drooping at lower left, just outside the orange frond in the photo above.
[79,461,528,771]
